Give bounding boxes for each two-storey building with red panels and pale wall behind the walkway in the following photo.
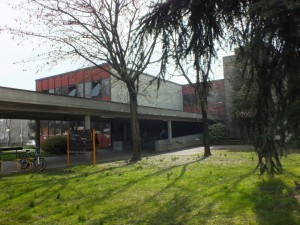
[36,64,225,149]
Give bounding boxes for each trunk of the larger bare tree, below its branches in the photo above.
[129,85,142,162]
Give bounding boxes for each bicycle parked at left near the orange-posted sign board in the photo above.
[16,148,47,172]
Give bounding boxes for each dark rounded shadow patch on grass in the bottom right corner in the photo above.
[251,178,300,225]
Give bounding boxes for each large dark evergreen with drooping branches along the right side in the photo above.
[144,0,300,174]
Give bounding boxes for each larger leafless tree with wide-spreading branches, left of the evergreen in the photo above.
[5,0,156,161]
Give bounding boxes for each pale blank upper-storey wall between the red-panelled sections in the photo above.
[111,75,183,111]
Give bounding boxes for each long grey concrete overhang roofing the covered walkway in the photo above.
[0,87,220,122]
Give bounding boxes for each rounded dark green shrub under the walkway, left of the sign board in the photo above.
[41,136,67,155]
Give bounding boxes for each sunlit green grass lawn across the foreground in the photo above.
[0,148,300,225]
